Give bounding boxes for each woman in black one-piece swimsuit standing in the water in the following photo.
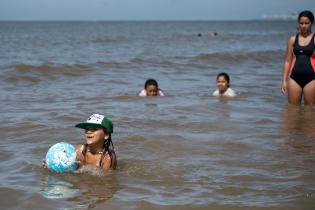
[282,11,315,105]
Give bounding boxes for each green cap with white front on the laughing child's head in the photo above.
[75,114,114,133]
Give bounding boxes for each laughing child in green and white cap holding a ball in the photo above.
[75,114,117,169]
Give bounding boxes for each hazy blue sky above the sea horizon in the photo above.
[0,0,315,20]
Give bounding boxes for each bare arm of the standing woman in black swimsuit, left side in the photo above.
[281,36,295,95]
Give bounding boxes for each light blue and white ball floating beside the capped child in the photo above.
[46,142,78,173]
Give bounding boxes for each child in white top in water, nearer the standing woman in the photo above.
[212,72,236,97]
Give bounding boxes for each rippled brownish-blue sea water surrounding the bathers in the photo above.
[0,21,315,210]
